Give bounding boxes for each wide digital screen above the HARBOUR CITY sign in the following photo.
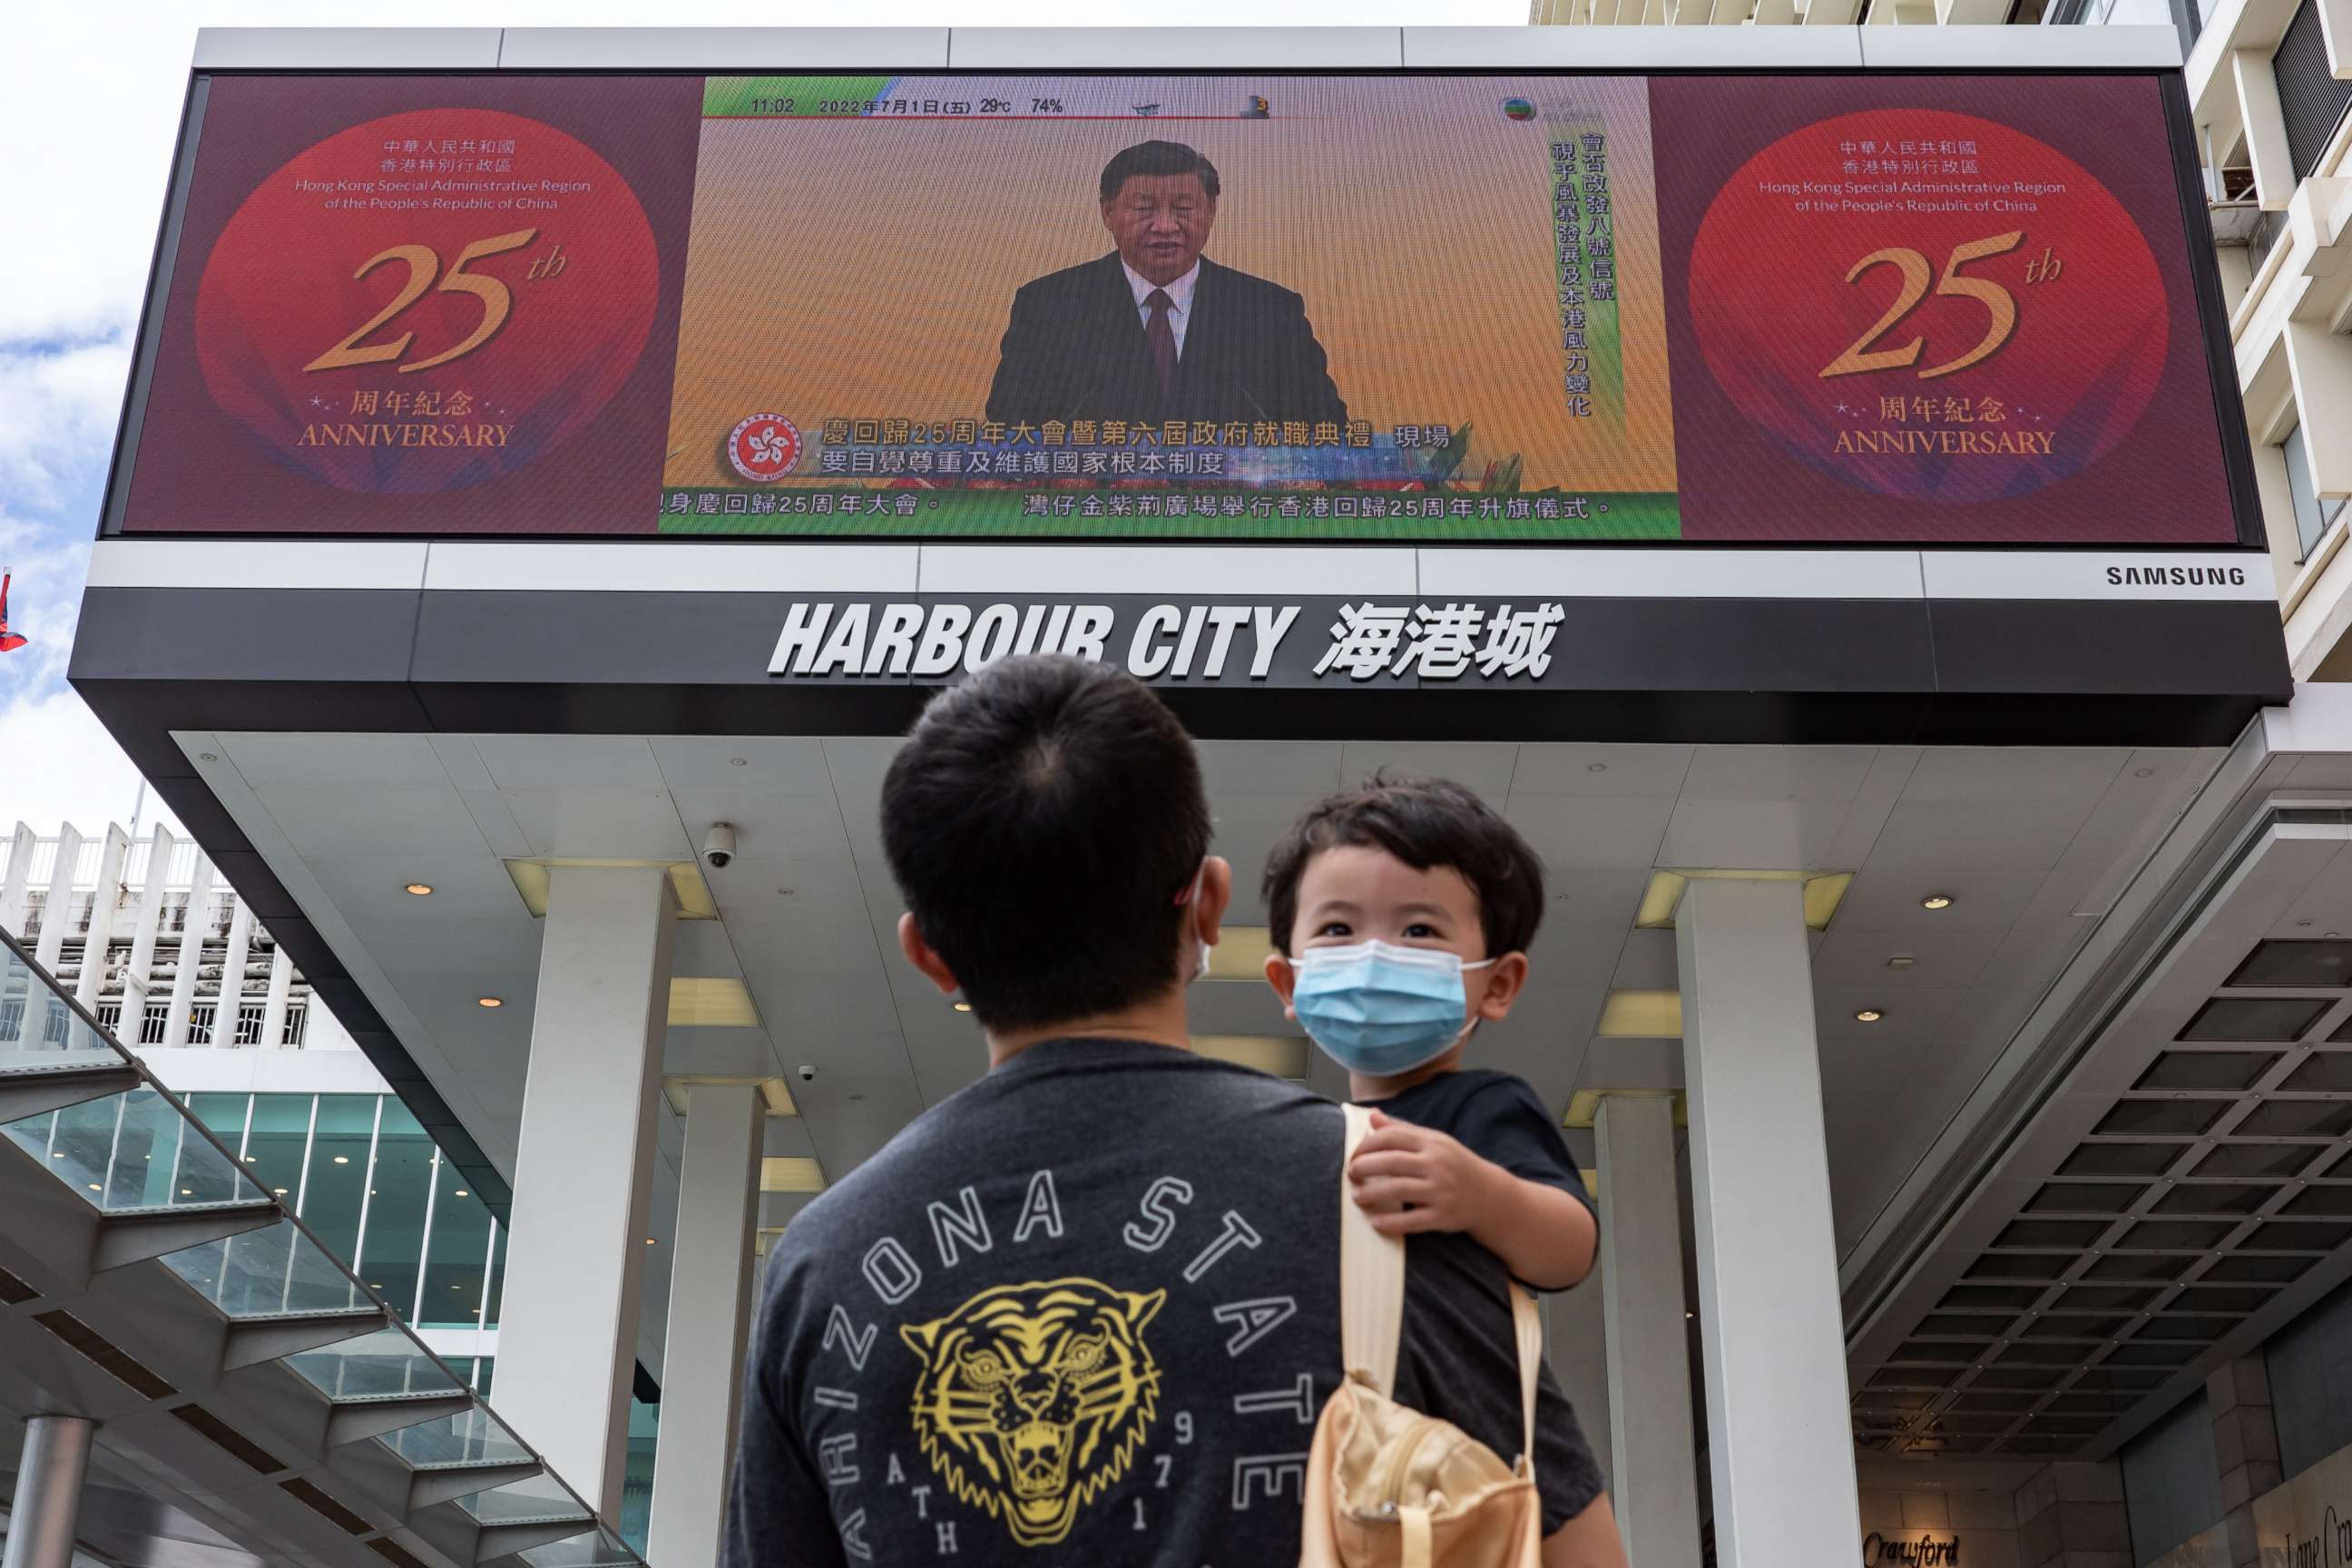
[118,73,2237,545]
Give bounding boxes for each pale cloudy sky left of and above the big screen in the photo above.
[0,0,1526,832]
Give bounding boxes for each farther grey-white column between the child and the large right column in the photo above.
[1592,1095,1698,1568]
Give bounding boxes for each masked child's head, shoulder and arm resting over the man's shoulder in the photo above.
[1263,779,1600,1290]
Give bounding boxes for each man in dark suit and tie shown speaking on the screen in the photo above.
[988,141,1348,426]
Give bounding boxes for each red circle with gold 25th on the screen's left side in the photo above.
[195,108,661,494]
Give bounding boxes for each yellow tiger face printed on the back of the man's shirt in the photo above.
[898,1279,1167,1547]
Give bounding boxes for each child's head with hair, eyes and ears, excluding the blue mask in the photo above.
[1263,779,1543,1044]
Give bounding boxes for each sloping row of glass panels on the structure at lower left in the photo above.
[0,931,616,1568]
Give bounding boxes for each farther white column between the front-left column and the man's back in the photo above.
[644,1083,767,1568]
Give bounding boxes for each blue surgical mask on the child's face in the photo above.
[1291,940,1494,1079]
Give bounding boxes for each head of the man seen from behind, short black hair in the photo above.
[882,656,1230,1037]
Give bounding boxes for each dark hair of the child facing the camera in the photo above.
[1259,773,1543,956]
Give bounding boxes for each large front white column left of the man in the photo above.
[496,865,675,1519]
